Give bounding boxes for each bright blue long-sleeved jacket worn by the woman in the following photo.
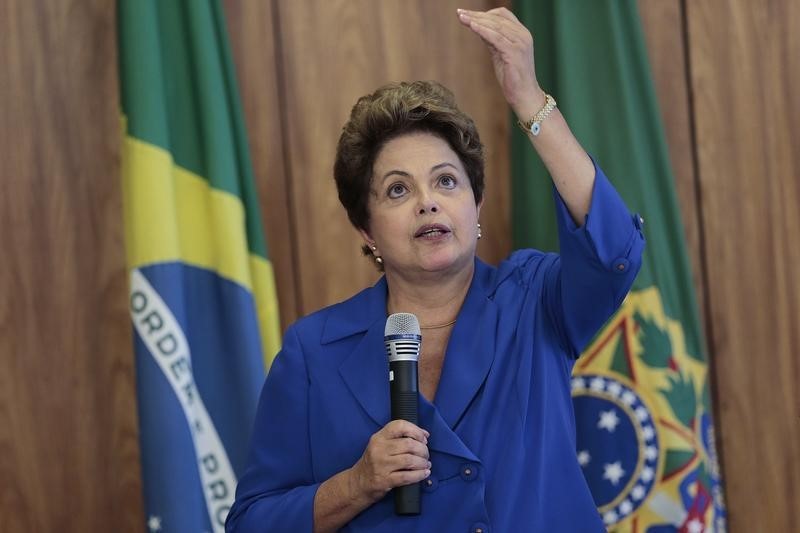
[226,163,644,533]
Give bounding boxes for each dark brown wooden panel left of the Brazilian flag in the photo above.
[0,0,144,533]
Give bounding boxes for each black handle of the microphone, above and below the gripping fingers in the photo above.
[389,361,420,515]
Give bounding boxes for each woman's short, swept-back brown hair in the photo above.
[333,81,484,238]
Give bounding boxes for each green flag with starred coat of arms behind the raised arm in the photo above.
[512,0,725,533]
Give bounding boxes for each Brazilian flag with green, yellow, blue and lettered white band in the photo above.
[118,0,279,533]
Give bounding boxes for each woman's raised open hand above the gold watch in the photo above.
[458,7,544,116]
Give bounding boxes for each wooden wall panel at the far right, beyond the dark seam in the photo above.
[686,0,800,533]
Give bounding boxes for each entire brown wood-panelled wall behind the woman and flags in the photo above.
[0,0,800,533]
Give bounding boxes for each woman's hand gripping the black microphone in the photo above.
[351,420,431,502]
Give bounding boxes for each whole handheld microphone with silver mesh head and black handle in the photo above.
[383,313,422,515]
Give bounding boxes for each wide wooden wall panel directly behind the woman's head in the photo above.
[275,0,510,314]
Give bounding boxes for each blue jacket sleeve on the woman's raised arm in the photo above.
[543,159,645,357]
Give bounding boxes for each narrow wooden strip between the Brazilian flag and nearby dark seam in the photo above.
[224,0,299,329]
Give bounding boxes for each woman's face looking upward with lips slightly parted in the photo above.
[361,133,480,277]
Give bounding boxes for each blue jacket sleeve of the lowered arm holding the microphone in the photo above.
[225,327,319,533]
